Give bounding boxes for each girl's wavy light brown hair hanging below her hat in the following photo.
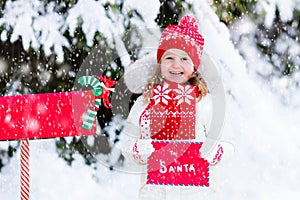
[144,64,208,104]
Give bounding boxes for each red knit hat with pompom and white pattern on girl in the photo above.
[157,16,204,70]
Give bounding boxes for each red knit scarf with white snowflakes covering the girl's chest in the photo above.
[140,83,197,140]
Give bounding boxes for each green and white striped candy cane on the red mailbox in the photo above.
[78,76,104,130]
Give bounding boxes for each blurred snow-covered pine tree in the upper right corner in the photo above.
[213,0,300,106]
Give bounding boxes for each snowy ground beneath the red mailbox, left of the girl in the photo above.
[0,140,139,200]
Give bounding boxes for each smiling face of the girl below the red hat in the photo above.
[160,49,194,83]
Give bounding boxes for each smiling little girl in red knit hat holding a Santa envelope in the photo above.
[123,16,223,200]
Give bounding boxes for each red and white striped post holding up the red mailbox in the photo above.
[20,139,30,200]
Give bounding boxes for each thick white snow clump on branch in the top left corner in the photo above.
[0,0,70,61]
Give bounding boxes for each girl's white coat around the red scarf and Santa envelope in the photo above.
[122,94,223,199]
